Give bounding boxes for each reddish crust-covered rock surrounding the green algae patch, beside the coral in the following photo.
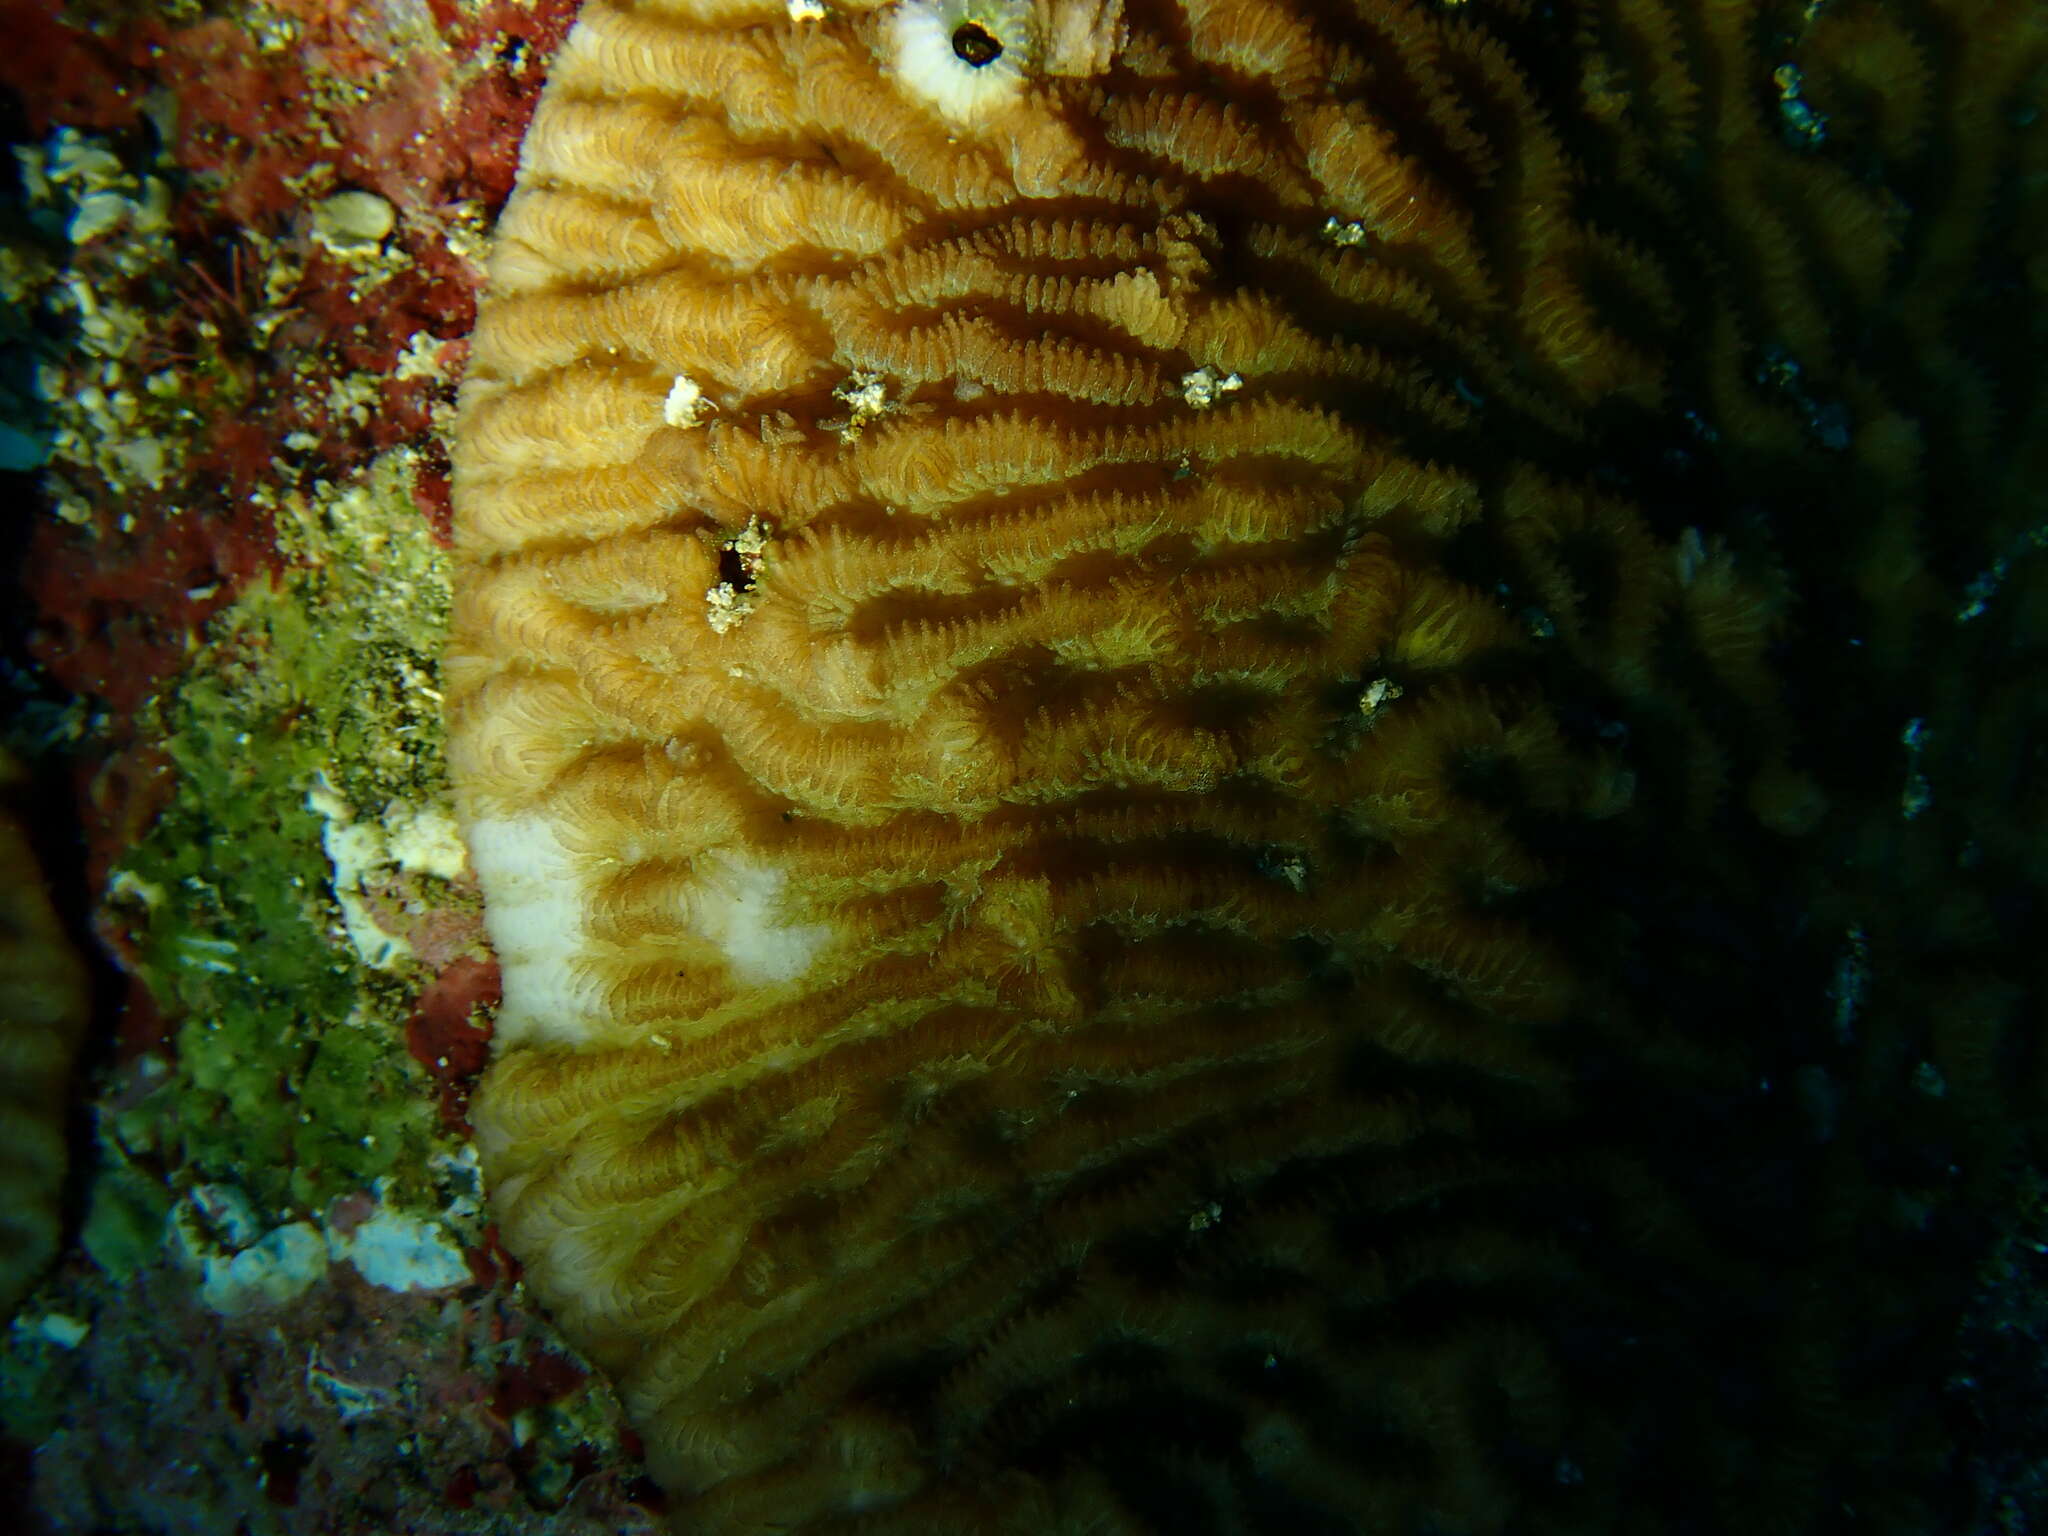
[0,0,659,1536]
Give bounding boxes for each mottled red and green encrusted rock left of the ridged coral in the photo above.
[0,0,655,1536]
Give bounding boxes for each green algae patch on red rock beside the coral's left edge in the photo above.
[109,453,457,1212]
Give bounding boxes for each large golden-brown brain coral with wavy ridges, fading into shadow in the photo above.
[446,0,2048,1534]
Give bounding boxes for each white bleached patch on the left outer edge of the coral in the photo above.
[456,815,604,1049]
